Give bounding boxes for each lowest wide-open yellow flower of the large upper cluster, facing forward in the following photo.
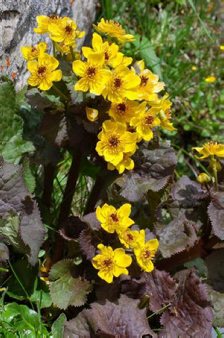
[96,120,137,166]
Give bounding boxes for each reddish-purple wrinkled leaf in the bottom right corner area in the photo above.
[160,270,213,338]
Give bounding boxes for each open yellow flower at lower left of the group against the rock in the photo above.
[27,54,62,90]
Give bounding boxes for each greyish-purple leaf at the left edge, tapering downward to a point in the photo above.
[0,163,45,265]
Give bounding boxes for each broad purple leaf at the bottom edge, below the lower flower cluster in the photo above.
[64,295,157,338]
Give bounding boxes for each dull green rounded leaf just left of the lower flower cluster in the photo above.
[49,259,92,309]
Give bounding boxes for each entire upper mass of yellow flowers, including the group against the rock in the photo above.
[21,16,175,174]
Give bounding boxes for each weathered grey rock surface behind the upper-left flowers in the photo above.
[0,0,97,88]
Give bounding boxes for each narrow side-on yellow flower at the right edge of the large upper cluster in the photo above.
[151,94,176,131]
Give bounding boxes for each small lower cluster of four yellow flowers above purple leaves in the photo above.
[92,203,159,283]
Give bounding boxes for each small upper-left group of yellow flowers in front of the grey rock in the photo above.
[21,15,84,90]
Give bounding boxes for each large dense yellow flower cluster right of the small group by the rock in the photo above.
[73,25,175,174]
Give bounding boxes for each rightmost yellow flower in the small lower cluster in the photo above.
[134,232,159,272]
